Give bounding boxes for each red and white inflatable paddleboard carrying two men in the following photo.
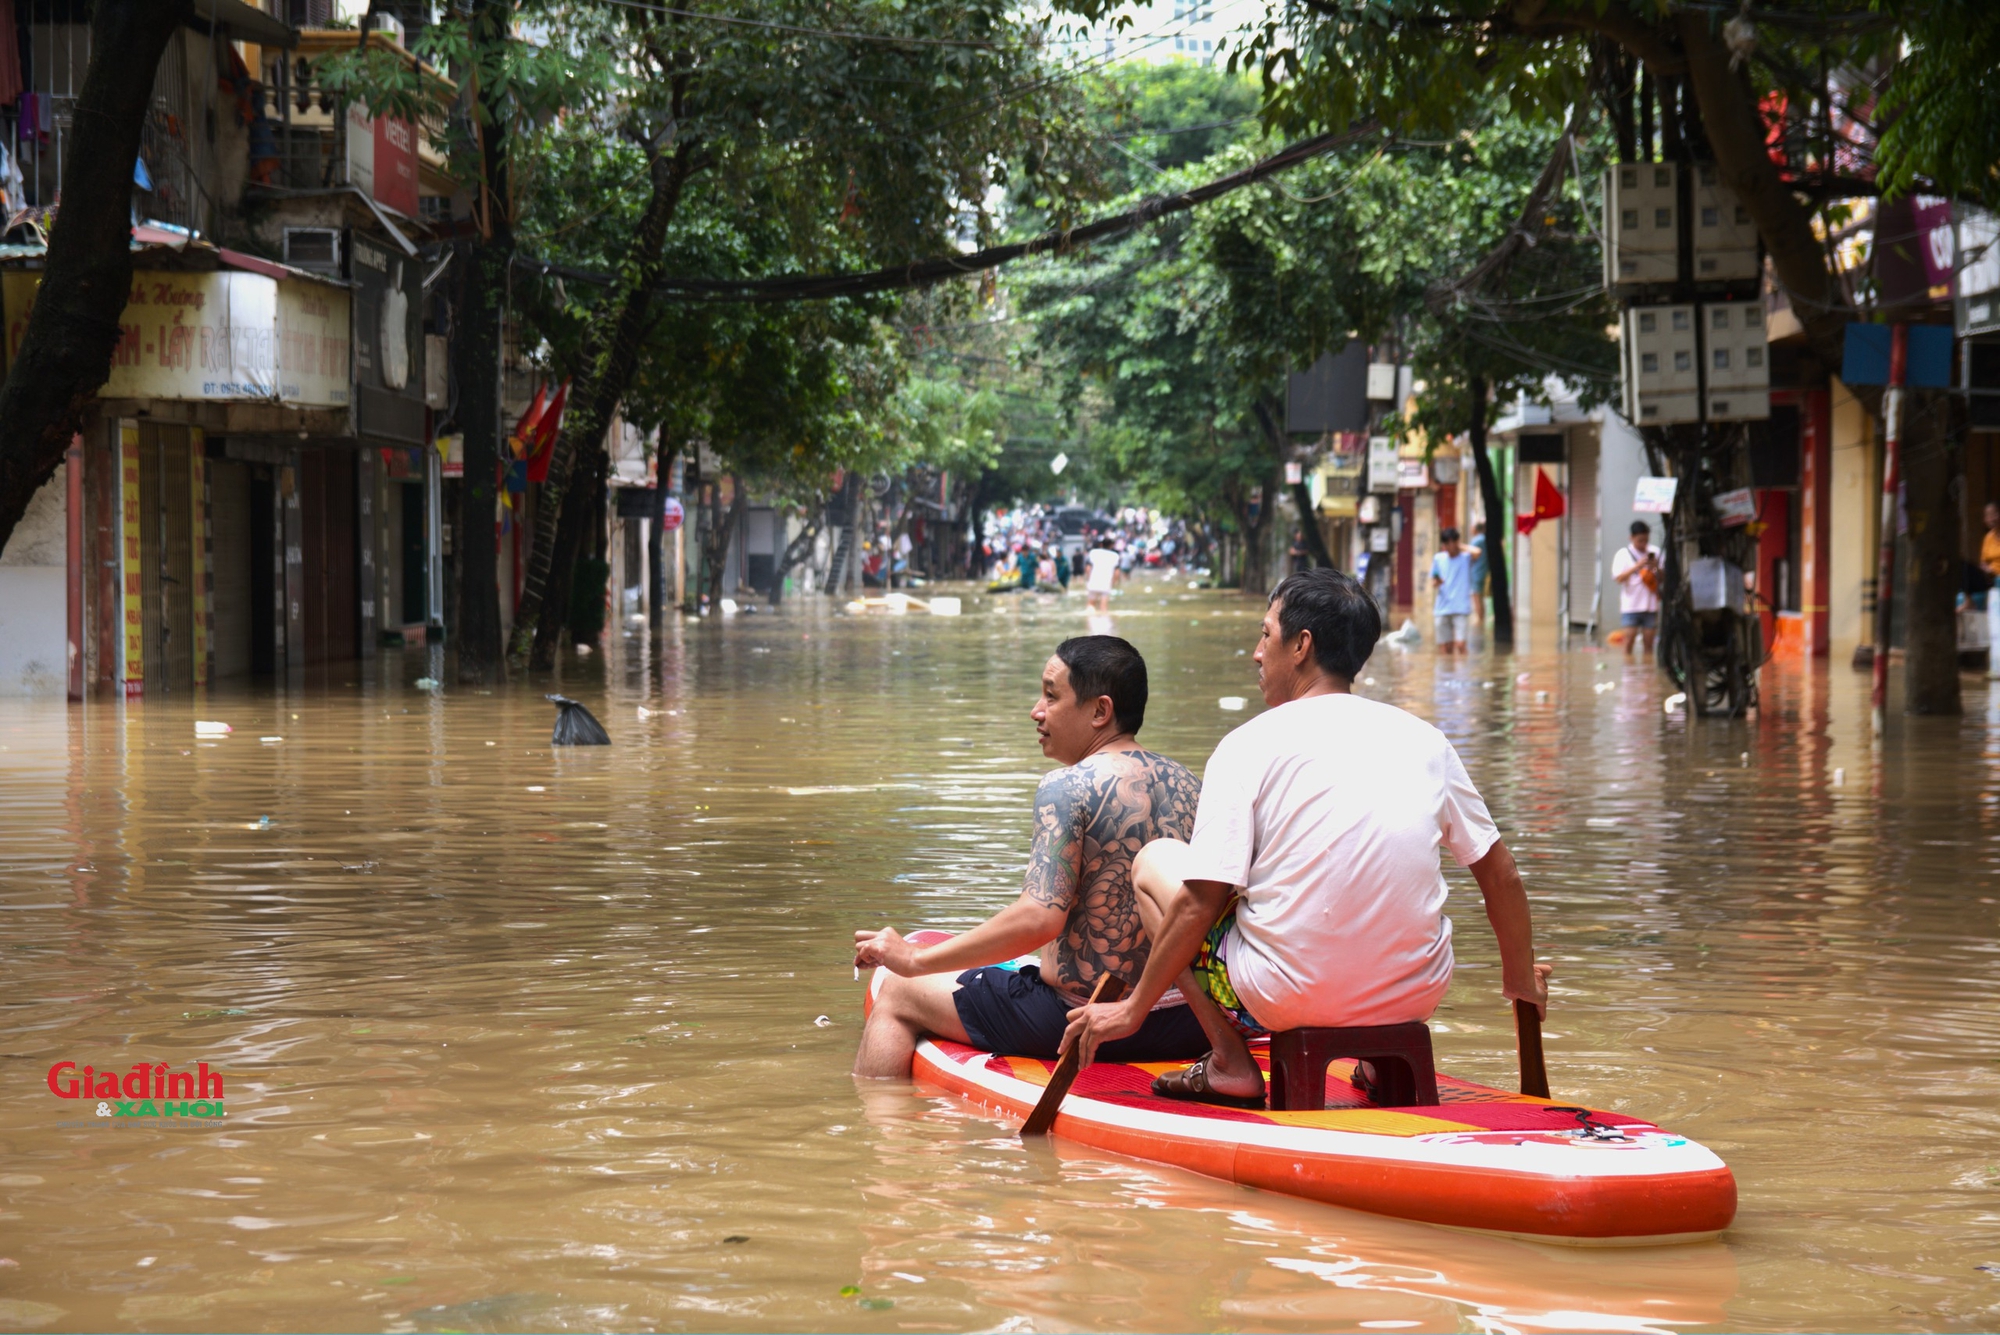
[868,931,1736,1245]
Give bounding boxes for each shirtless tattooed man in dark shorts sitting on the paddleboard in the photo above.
[854,636,1208,1077]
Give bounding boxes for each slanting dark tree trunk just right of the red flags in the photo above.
[508,135,696,669]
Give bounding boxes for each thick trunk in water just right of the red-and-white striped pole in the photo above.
[1902,390,1962,713]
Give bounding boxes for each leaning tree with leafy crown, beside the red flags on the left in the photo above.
[496,0,1074,666]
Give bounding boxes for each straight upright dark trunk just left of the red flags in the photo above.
[452,0,514,685]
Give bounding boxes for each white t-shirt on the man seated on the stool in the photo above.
[1192,695,1500,1029]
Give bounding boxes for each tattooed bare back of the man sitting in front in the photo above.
[1026,747,1202,997]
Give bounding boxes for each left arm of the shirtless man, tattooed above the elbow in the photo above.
[854,767,1088,977]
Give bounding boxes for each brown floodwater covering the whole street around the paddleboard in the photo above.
[0,584,2000,1333]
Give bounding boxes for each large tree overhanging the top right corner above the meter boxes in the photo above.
[1096,0,1968,713]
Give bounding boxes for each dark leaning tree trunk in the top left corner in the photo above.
[0,0,194,548]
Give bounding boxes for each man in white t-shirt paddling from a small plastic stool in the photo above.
[1064,570,1548,1105]
